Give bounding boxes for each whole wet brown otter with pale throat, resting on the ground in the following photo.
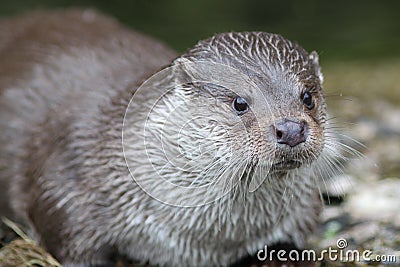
[0,10,335,266]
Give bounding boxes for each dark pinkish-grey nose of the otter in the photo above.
[272,119,307,147]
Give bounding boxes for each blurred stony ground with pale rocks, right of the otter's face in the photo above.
[311,61,400,266]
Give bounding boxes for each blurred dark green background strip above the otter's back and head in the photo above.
[0,0,400,60]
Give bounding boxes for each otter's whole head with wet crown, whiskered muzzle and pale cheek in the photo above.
[124,32,326,207]
